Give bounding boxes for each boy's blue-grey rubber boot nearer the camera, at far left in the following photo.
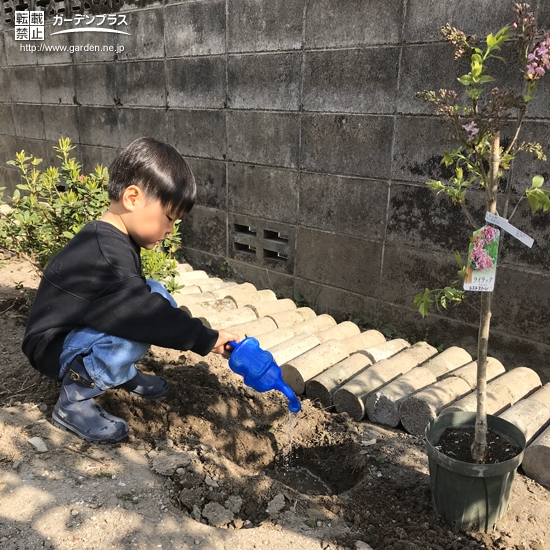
[52,357,129,443]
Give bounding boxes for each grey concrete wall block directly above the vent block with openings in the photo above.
[227,163,298,224]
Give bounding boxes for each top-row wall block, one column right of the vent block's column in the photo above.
[305,0,403,48]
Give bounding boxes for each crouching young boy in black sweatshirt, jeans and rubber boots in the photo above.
[22,138,239,442]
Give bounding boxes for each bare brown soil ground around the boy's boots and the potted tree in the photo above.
[0,260,550,550]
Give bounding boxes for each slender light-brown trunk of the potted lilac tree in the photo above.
[471,133,500,462]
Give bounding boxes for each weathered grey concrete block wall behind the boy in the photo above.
[0,0,550,379]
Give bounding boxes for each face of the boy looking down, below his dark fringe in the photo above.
[126,196,175,250]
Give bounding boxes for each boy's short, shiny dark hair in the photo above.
[107,137,197,218]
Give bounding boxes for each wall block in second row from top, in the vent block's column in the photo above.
[227,53,302,111]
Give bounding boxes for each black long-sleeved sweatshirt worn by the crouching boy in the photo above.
[22,221,218,380]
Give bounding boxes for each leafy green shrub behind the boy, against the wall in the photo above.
[0,138,181,292]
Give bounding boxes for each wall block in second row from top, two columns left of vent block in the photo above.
[116,60,166,108]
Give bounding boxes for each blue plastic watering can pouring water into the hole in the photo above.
[229,337,302,413]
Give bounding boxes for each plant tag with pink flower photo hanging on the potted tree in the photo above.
[464,225,500,292]
